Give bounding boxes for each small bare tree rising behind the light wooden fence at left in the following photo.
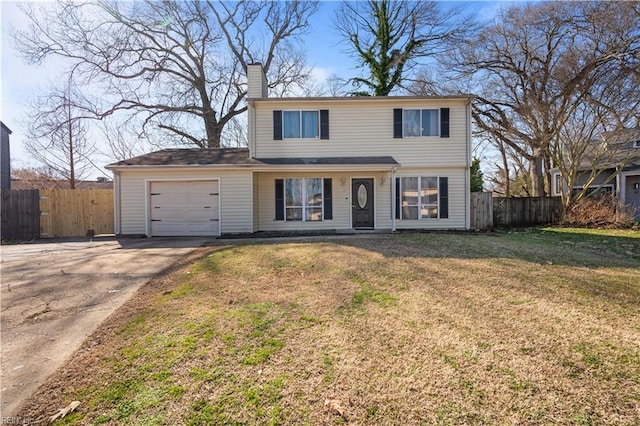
[25,78,96,189]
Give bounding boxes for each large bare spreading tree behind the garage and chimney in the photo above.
[14,0,318,147]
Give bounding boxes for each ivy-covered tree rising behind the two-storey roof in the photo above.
[334,0,473,96]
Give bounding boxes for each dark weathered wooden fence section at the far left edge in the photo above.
[0,189,40,241]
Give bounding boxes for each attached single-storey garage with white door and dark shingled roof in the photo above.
[107,148,262,238]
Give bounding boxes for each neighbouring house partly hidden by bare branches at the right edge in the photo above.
[552,128,640,220]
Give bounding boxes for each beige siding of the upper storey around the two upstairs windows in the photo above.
[251,99,469,167]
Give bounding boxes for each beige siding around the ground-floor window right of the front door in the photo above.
[396,168,469,230]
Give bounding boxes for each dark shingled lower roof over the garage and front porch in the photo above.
[106,148,399,169]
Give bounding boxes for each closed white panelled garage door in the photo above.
[149,180,220,237]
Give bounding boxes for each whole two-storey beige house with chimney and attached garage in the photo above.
[107,64,472,236]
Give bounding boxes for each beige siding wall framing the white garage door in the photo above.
[119,168,252,235]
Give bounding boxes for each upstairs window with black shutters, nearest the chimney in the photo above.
[273,109,329,140]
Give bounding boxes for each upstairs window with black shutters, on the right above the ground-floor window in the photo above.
[393,108,449,138]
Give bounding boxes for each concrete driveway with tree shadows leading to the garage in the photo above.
[0,238,206,418]
